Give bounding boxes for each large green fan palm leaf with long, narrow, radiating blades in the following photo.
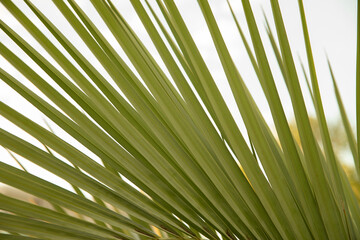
[0,0,360,240]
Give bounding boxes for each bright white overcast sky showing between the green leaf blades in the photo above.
[0,0,356,185]
